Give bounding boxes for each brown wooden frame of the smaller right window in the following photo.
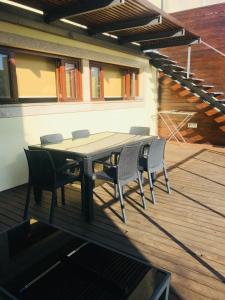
[89,61,139,101]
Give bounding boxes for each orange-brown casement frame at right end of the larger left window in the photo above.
[56,59,83,102]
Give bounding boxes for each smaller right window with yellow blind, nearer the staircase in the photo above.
[90,62,139,101]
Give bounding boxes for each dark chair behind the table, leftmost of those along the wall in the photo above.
[40,133,79,172]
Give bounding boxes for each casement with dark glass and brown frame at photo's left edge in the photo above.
[0,53,17,102]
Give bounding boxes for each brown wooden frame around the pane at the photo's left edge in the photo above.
[0,48,18,104]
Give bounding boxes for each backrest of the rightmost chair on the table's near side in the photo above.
[148,138,166,169]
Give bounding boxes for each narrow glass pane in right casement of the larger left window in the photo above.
[65,63,77,98]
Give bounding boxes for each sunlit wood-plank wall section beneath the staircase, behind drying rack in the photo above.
[158,75,225,146]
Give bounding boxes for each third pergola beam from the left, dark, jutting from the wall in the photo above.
[119,28,185,44]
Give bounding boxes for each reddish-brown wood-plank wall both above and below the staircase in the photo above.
[159,4,225,146]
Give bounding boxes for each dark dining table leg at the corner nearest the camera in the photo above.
[81,158,94,221]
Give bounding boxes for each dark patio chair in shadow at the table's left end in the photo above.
[23,149,80,223]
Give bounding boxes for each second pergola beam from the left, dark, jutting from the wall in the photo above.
[88,15,162,35]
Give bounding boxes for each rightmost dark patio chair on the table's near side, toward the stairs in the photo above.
[139,138,171,204]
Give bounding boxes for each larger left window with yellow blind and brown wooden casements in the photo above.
[0,48,82,103]
